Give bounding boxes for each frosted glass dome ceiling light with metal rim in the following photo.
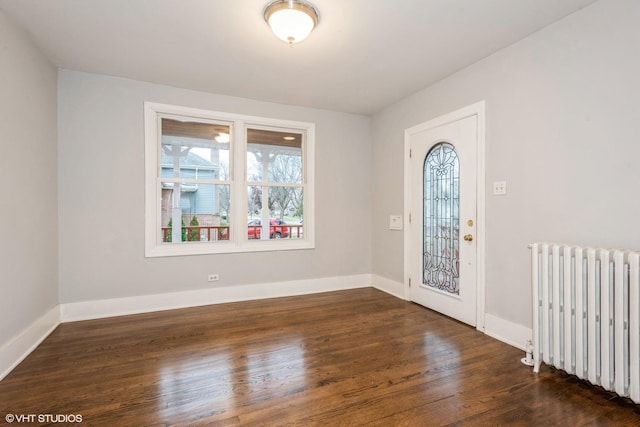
[264,0,319,45]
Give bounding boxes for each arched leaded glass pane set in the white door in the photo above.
[422,142,460,295]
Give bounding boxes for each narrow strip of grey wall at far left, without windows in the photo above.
[0,10,58,362]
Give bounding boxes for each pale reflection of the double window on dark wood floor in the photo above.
[157,337,306,418]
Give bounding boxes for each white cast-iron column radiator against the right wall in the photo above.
[530,243,640,403]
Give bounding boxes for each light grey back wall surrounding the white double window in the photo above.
[58,70,372,303]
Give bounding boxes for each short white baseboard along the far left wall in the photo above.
[0,305,60,380]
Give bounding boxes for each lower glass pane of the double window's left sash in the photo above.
[160,182,230,243]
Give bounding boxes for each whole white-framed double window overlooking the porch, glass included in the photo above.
[145,103,315,257]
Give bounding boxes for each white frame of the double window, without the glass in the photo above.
[144,102,315,258]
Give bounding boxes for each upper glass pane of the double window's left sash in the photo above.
[160,118,230,181]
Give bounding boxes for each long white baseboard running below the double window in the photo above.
[60,274,371,322]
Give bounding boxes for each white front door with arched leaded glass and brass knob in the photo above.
[405,108,478,326]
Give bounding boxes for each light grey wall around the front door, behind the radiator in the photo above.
[372,0,640,327]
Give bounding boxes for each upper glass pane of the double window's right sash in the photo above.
[247,129,302,184]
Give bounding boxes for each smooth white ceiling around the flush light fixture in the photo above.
[0,0,595,114]
